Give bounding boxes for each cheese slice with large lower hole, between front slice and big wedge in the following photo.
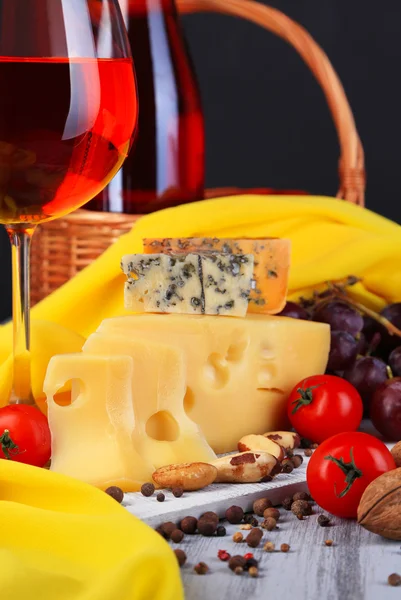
[83,331,215,469]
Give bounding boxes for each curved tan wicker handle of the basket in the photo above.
[177,0,366,206]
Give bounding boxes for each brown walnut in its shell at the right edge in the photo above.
[358,468,401,540]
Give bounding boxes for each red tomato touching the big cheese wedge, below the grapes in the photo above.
[287,375,363,443]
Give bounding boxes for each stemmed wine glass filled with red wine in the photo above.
[0,0,138,404]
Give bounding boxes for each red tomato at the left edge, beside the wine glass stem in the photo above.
[0,404,51,467]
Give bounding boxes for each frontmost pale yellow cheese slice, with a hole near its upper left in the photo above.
[44,353,154,492]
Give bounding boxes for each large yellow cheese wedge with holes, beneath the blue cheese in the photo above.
[93,314,330,452]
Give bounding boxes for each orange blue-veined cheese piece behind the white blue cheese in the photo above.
[143,238,291,314]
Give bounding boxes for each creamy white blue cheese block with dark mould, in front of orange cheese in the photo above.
[121,253,254,317]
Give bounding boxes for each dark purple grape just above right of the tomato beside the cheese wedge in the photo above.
[343,356,387,414]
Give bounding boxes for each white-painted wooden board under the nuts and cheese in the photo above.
[123,458,309,527]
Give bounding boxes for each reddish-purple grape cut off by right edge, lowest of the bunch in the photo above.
[370,377,401,442]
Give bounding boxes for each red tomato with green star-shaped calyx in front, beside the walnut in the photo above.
[306,432,396,518]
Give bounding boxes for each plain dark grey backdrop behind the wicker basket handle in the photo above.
[0,0,401,319]
